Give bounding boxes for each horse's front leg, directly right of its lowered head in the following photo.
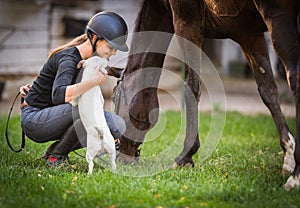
[170,1,204,168]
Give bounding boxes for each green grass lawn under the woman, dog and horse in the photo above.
[0,112,300,208]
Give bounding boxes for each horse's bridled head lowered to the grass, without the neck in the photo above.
[108,64,159,163]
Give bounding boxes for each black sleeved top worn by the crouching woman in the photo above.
[25,47,82,109]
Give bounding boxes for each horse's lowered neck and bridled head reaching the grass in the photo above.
[107,1,174,162]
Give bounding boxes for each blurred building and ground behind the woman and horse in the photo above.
[0,0,295,116]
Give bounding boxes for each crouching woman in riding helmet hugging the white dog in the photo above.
[20,12,128,166]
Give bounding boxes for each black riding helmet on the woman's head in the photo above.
[86,12,128,52]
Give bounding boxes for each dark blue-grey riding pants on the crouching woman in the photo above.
[21,103,126,155]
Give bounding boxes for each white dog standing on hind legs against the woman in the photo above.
[72,56,116,174]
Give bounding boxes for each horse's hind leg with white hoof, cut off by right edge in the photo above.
[254,0,300,189]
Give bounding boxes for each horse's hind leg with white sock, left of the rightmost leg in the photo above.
[236,33,295,176]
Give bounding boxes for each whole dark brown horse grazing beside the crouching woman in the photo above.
[110,0,300,189]
